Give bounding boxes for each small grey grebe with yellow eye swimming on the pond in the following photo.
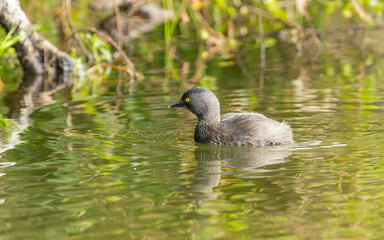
[169,87,293,146]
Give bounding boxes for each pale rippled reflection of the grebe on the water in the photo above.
[186,145,292,199]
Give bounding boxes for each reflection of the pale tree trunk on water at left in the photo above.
[0,73,72,153]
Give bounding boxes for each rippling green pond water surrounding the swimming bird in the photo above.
[0,27,384,240]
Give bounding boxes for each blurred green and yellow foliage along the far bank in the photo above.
[0,0,384,88]
